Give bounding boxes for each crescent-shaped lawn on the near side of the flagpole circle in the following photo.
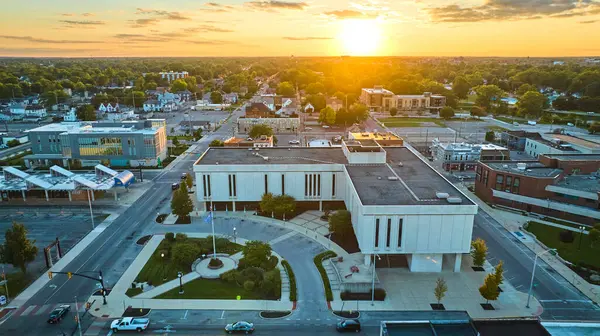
[155,279,264,300]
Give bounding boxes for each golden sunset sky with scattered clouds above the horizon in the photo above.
[0,0,600,57]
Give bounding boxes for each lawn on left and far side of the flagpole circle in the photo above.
[136,238,242,286]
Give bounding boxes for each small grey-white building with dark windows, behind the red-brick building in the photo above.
[431,139,510,171]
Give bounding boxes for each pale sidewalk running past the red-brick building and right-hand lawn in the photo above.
[457,185,600,303]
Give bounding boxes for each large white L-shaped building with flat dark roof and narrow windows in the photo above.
[194,136,477,272]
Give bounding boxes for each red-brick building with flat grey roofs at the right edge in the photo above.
[475,154,600,224]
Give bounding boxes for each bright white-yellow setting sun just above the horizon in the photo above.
[338,20,381,56]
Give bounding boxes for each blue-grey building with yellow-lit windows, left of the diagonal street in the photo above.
[24,119,167,167]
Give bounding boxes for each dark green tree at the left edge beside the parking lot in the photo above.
[0,222,38,274]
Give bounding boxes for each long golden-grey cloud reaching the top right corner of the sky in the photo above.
[426,0,600,22]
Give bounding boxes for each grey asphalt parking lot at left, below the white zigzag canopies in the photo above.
[0,213,105,273]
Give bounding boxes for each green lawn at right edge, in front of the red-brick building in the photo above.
[527,221,600,267]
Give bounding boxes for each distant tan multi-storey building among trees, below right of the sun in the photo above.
[360,86,446,113]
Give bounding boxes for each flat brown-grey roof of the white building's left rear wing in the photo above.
[196,147,348,165]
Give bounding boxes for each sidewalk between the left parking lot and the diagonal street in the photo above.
[8,214,119,307]
